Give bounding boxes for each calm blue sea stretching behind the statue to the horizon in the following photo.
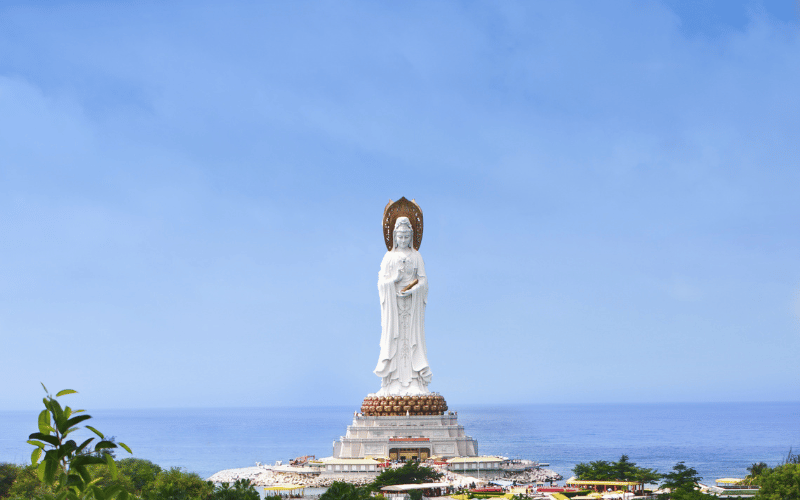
[0,402,800,482]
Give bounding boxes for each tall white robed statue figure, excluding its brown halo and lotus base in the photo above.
[375,217,431,396]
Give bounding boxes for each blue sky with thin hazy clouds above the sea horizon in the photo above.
[0,0,800,409]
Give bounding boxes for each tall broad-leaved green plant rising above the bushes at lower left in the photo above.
[28,384,131,500]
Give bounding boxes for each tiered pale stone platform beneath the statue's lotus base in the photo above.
[333,412,478,460]
